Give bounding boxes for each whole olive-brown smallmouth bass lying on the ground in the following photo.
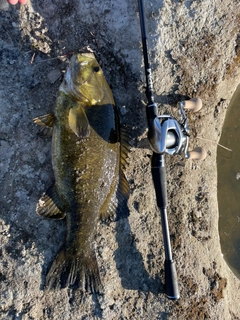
[34,53,129,292]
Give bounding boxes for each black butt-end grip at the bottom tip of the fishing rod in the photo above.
[165,260,180,300]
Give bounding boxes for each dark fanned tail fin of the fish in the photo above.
[46,247,102,293]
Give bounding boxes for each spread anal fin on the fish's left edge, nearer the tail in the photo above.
[36,184,65,219]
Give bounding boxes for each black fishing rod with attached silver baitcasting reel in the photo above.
[138,0,206,300]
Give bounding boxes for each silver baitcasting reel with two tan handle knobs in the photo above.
[148,98,207,160]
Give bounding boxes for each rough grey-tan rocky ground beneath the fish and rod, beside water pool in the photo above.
[0,0,240,320]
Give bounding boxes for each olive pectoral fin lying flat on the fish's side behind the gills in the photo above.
[68,106,90,138]
